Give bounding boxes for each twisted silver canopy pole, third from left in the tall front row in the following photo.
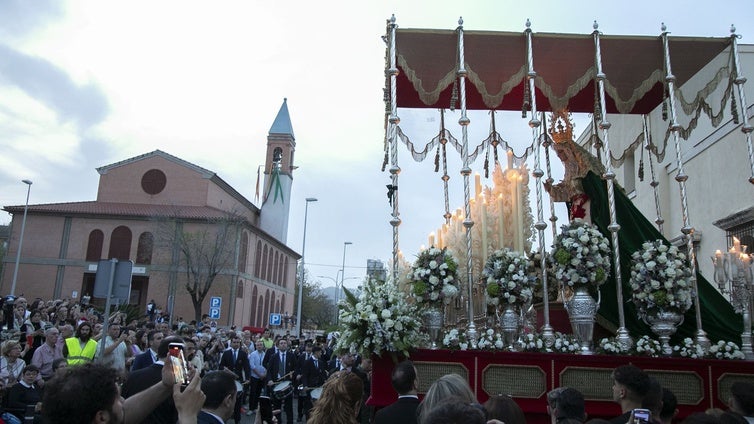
[518,19,555,346]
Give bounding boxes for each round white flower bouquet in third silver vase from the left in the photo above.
[550,218,610,288]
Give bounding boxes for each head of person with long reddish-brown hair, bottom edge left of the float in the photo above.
[306,371,364,424]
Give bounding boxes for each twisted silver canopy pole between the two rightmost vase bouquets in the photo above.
[592,21,634,349]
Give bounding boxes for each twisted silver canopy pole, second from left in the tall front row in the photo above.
[457,17,477,342]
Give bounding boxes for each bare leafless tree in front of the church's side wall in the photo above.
[159,213,245,322]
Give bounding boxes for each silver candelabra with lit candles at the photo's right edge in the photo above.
[712,237,754,360]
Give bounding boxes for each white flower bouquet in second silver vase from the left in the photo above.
[482,247,535,307]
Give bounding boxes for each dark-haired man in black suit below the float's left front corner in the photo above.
[374,361,419,424]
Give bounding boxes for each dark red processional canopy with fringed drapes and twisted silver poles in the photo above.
[383,16,754,350]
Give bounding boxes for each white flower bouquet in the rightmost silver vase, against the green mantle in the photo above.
[630,240,693,317]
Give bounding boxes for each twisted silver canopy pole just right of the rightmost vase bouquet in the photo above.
[662,23,710,352]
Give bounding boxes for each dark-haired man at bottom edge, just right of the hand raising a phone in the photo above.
[196,371,238,424]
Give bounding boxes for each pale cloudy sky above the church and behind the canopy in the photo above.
[0,0,754,287]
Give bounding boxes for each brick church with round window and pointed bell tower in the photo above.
[0,102,300,327]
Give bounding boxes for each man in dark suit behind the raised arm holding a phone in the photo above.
[121,333,183,424]
